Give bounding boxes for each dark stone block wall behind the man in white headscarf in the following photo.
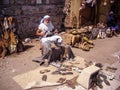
[0,0,65,38]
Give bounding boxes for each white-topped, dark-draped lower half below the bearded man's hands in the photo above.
[35,35,75,66]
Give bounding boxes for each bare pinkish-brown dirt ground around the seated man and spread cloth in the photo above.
[0,35,120,90]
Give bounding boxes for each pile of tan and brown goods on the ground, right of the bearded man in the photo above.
[62,27,94,51]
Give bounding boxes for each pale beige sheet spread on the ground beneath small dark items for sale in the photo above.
[13,57,85,89]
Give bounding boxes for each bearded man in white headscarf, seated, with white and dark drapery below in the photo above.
[34,15,74,65]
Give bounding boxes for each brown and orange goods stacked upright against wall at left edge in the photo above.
[0,17,24,58]
